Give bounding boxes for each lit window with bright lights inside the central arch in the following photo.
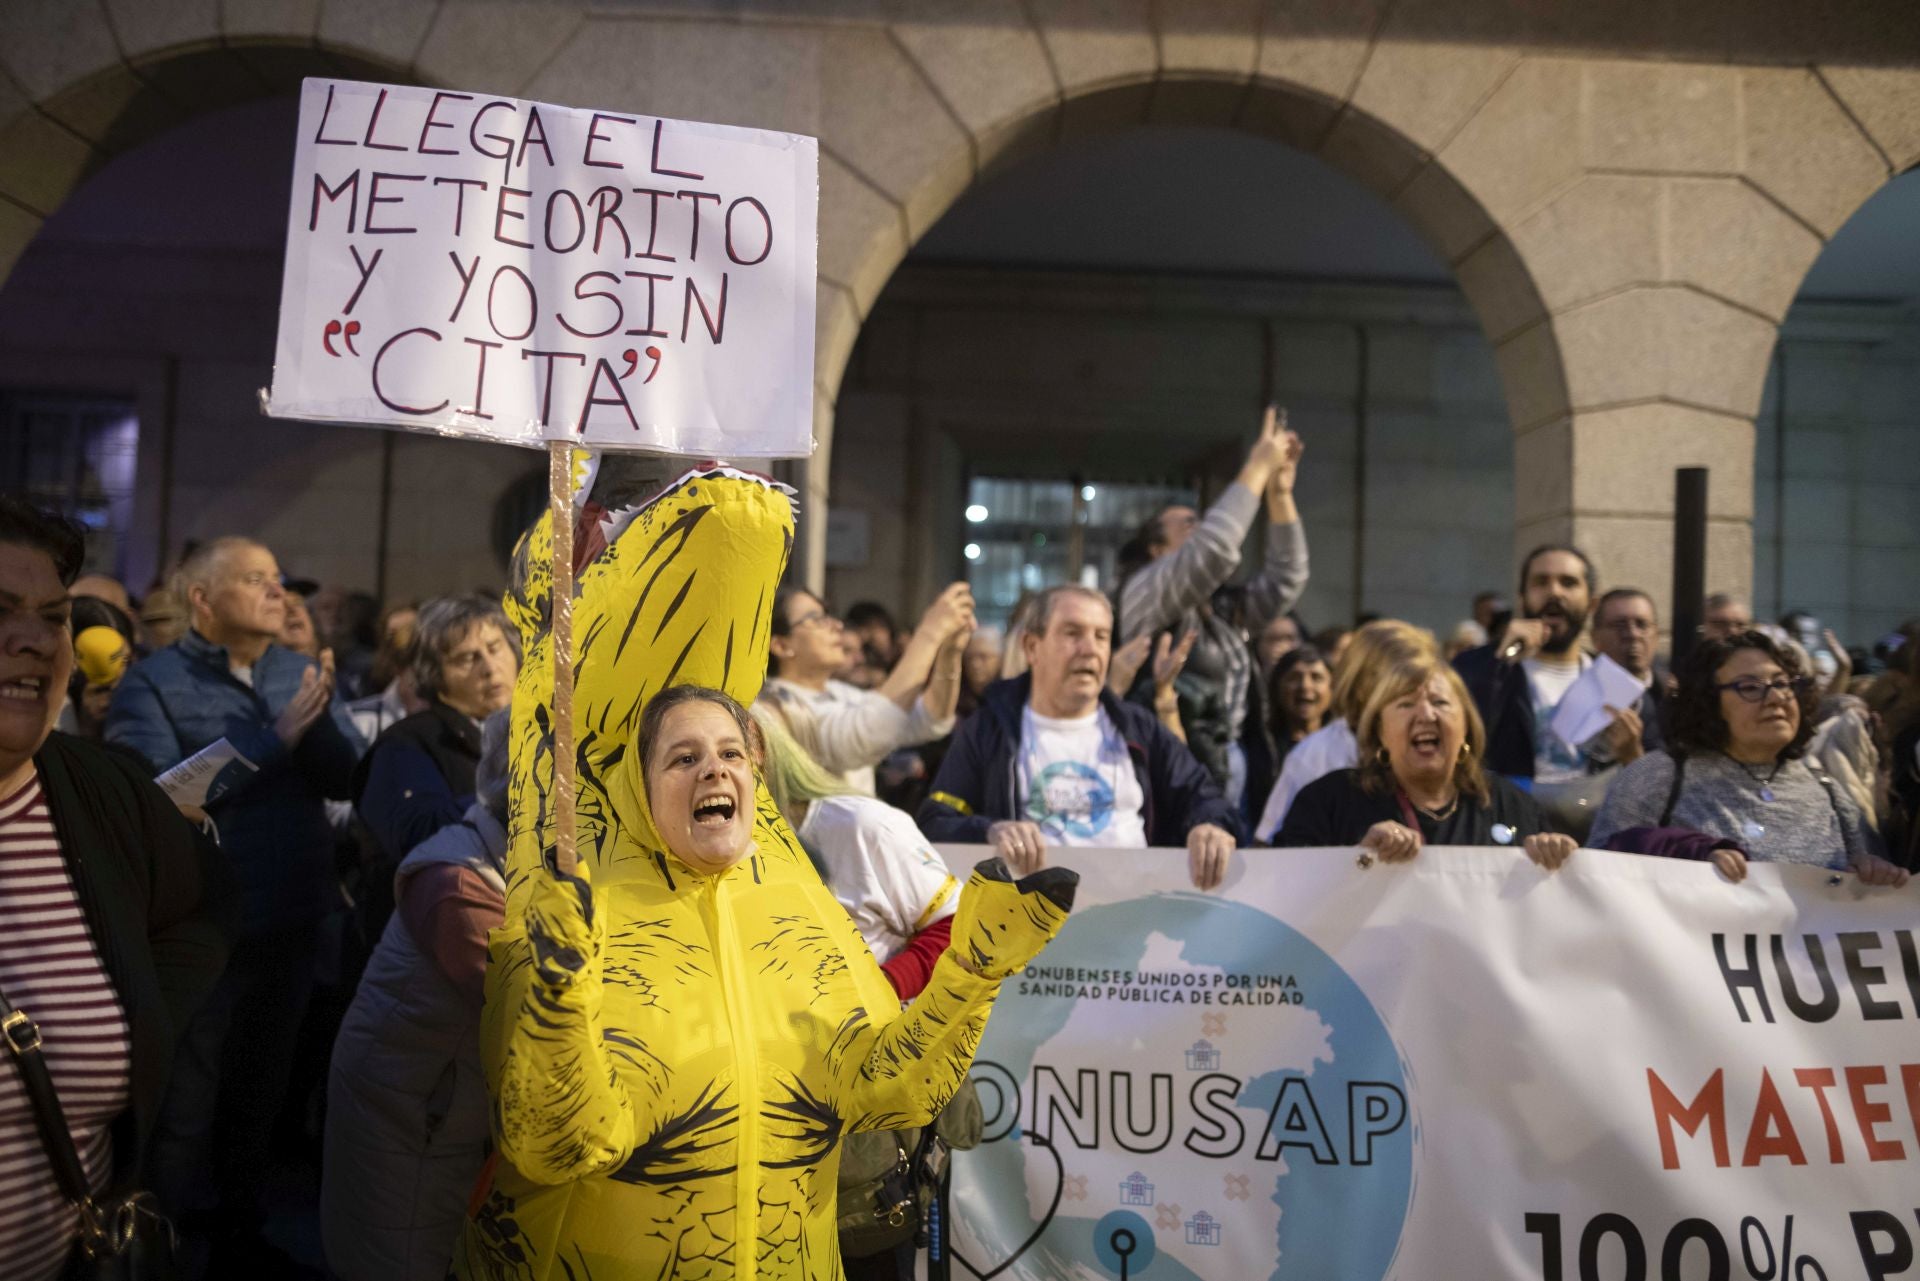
[960,476,1194,626]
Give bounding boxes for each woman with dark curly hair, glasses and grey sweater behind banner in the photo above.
[1590,632,1907,885]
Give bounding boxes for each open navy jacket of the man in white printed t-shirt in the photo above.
[916,676,1246,847]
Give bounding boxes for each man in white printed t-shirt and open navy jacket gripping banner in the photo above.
[918,586,1240,889]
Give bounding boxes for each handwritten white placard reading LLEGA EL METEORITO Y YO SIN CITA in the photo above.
[267,81,820,457]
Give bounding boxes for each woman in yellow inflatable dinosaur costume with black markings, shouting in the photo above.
[453,467,1077,1281]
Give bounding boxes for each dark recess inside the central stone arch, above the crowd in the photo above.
[814,77,1551,626]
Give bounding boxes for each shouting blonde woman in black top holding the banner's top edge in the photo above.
[1275,651,1574,870]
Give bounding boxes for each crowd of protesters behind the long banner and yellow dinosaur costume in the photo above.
[0,415,1920,1281]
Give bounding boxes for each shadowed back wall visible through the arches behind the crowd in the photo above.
[0,230,1920,641]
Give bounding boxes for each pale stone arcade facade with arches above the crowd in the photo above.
[11,0,1920,610]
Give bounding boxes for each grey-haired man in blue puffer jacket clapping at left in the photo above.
[106,538,363,1275]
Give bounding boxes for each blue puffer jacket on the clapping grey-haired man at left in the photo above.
[106,632,365,935]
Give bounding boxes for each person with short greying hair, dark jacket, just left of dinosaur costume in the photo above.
[353,595,520,943]
